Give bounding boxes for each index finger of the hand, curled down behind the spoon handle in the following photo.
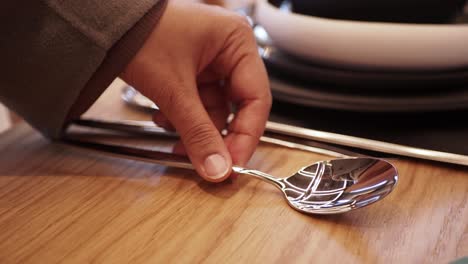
[218,23,272,165]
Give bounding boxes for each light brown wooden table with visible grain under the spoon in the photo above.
[0,81,468,263]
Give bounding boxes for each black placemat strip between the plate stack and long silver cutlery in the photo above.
[270,101,468,155]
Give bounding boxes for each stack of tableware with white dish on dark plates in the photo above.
[255,0,468,113]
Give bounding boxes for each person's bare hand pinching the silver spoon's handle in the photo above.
[121,1,271,182]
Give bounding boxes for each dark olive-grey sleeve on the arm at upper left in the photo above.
[0,0,166,138]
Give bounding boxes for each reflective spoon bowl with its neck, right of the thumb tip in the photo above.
[234,158,398,214]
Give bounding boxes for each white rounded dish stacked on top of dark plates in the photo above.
[255,0,468,71]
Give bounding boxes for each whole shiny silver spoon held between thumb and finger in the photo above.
[64,137,398,214]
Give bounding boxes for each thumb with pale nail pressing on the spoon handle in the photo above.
[155,84,232,182]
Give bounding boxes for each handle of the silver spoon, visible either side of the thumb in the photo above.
[62,137,284,189]
